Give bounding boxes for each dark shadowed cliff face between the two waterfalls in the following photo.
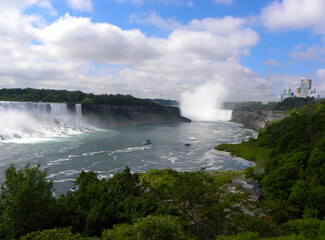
[81,104,191,127]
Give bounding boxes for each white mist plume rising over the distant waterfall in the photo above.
[181,81,232,121]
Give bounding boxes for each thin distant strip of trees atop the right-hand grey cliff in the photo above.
[222,97,315,110]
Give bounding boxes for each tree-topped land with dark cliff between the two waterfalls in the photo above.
[0,88,191,127]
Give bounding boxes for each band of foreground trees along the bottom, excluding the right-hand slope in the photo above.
[0,165,275,240]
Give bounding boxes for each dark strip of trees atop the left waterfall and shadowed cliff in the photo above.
[0,88,159,106]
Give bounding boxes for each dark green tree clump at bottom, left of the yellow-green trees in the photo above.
[59,167,169,236]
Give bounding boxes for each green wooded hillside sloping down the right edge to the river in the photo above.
[217,99,325,236]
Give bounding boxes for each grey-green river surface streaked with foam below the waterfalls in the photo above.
[0,122,255,195]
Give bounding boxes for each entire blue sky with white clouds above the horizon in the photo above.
[0,0,325,102]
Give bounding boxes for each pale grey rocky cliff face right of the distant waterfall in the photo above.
[231,109,289,131]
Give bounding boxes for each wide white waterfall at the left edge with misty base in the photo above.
[0,101,94,142]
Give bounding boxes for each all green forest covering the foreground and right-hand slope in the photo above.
[0,100,325,240]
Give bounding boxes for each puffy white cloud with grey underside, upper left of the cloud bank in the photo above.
[35,14,157,64]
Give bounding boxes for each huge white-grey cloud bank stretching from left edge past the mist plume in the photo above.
[0,1,274,100]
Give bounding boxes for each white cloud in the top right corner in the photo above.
[260,0,325,33]
